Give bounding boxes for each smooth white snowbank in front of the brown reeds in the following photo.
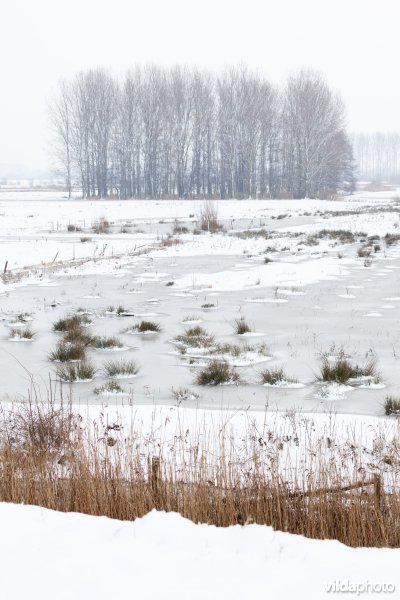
[0,503,400,600]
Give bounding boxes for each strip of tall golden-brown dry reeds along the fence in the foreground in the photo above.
[0,403,400,547]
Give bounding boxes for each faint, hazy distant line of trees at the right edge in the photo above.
[352,131,400,183]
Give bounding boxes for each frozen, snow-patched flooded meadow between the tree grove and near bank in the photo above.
[0,192,400,415]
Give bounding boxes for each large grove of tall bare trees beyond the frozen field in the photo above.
[50,66,353,198]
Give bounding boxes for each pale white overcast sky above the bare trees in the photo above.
[0,0,400,172]
